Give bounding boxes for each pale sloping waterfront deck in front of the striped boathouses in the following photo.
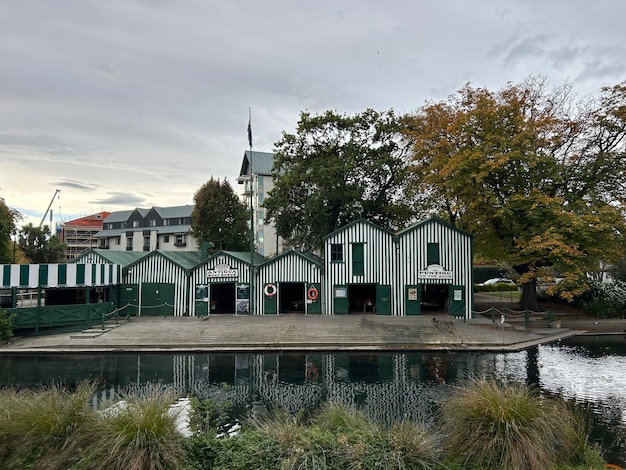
[0,314,585,355]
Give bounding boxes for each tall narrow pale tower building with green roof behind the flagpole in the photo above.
[237,150,284,258]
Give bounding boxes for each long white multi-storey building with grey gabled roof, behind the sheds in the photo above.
[96,205,198,251]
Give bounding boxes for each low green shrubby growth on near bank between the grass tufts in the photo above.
[187,403,441,470]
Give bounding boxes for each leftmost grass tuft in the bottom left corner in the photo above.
[0,382,96,468]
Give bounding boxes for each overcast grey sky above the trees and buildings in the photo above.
[0,0,626,228]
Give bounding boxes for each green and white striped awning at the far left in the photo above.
[0,263,121,289]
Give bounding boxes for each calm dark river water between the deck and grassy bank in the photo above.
[0,335,626,466]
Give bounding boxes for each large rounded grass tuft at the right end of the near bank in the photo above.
[441,379,587,469]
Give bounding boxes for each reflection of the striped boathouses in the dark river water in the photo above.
[90,353,512,424]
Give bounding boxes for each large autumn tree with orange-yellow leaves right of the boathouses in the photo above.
[406,77,626,309]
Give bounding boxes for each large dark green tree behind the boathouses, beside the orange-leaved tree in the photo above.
[264,109,413,250]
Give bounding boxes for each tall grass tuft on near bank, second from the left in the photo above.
[89,385,184,470]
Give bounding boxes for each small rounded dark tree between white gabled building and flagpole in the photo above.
[191,177,250,252]
